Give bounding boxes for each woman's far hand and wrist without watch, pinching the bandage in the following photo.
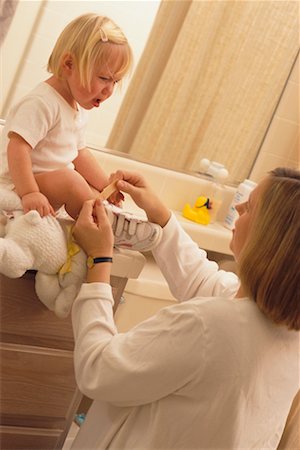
[111,170,171,227]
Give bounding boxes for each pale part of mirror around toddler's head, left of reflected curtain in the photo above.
[0,0,160,144]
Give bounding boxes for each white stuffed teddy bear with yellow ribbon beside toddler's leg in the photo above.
[0,188,86,317]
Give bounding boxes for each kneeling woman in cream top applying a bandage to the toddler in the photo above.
[72,169,300,450]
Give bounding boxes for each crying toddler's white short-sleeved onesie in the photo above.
[0,82,87,189]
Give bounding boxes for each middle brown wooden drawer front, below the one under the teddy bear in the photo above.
[0,344,80,429]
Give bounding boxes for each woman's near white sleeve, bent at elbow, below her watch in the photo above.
[72,283,206,406]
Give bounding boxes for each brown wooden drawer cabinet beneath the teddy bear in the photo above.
[0,273,82,450]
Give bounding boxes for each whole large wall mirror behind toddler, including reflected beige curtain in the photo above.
[1,1,299,183]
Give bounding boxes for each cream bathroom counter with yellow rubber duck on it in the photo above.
[93,149,235,256]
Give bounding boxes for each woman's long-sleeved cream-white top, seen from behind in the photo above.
[72,217,299,450]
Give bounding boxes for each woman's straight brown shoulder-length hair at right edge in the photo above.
[239,168,300,330]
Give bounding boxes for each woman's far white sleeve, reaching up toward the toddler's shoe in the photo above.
[152,214,239,301]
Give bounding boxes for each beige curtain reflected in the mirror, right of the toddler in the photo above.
[107,0,299,182]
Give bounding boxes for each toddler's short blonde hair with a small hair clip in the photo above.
[47,13,133,88]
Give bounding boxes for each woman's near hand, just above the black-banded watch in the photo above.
[73,199,114,257]
